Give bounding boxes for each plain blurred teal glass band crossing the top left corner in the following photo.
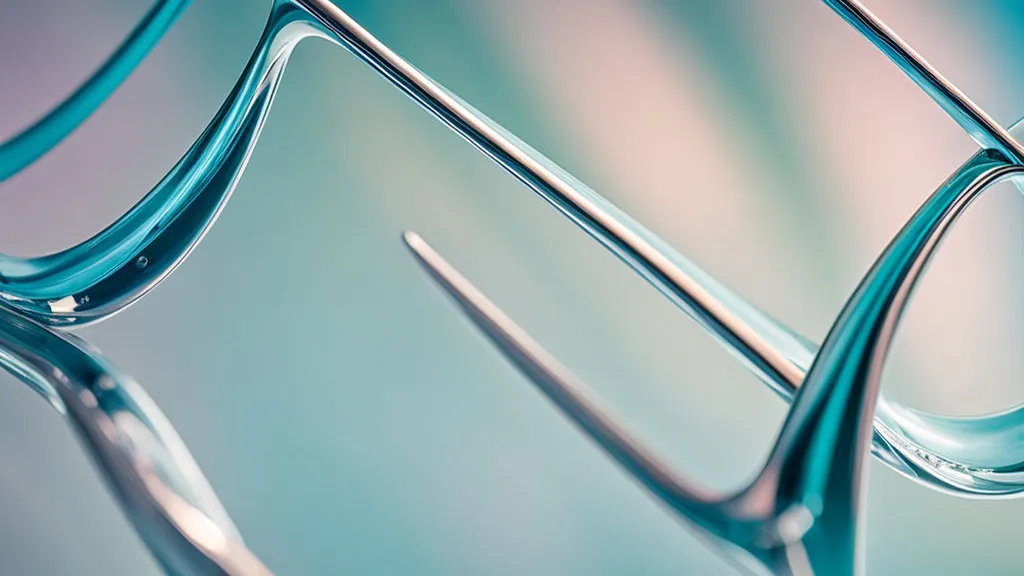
[0,0,191,182]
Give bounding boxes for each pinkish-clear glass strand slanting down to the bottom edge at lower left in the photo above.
[0,303,270,576]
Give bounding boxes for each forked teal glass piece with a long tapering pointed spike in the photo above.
[406,151,1024,575]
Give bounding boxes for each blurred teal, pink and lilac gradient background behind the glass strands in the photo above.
[0,0,1024,576]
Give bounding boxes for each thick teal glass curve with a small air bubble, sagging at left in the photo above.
[0,2,309,326]
